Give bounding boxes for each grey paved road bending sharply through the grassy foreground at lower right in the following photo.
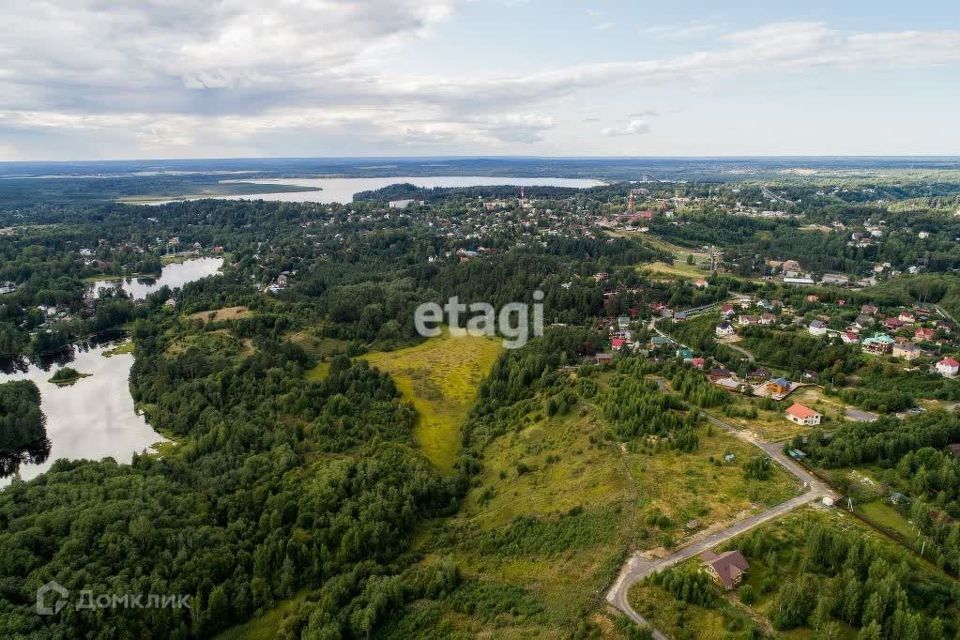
[607,404,837,640]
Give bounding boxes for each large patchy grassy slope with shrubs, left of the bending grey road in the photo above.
[385,368,796,638]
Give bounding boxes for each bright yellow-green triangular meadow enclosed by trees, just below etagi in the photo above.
[363,333,502,473]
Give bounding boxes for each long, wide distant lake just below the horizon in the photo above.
[150,176,606,204]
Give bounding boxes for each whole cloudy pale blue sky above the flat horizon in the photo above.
[0,0,960,161]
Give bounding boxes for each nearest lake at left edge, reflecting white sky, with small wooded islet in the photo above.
[0,344,165,487]
